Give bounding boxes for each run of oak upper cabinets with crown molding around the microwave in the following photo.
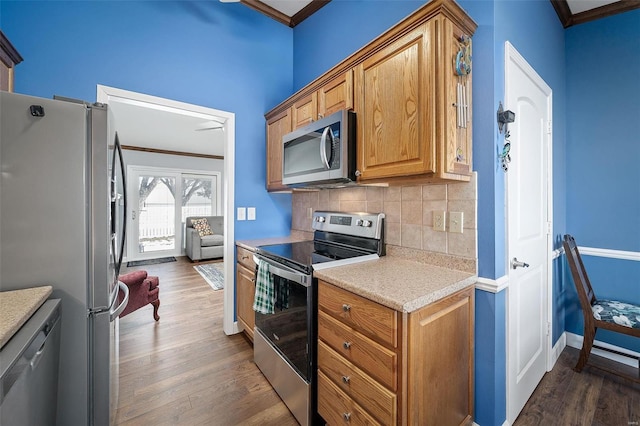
[265,0,477,189]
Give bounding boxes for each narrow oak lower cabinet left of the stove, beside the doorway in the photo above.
[236,247,256,341]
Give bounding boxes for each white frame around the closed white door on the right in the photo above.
[504,41,555,424]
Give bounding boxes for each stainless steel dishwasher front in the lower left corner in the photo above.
[0,299,61,426]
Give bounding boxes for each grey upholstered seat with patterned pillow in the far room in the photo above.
[185,216,224,262]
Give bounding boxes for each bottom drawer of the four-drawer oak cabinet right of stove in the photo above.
[318,371,381,425]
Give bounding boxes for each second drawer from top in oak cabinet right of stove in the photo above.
[318,312,398,392]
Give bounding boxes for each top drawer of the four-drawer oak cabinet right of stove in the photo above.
[318,282,398,348]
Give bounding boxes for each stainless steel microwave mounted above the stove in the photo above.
[282,110,356,187]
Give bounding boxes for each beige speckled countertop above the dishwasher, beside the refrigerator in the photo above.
[0,286,53,348]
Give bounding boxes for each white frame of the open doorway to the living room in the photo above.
[96,85,239,335]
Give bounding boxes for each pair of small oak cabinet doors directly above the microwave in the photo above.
[291,70,353,130]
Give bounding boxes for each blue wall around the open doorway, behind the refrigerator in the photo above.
[0,1,293,239]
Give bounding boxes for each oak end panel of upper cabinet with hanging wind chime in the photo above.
[437,18,473,181]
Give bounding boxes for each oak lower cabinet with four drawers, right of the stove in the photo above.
[318,281,474,425]
